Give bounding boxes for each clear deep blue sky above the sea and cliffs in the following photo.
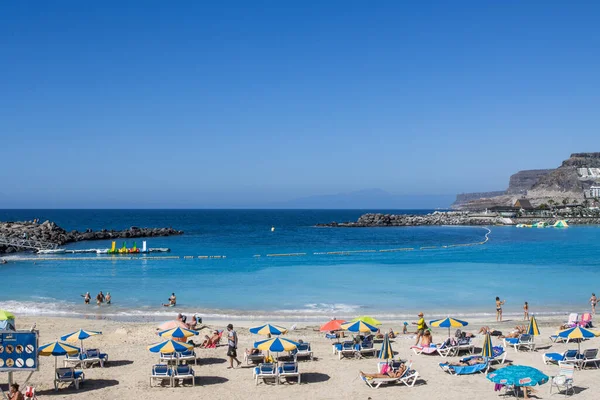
[0,0,600,208]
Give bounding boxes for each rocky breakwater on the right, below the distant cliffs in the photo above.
[317,211,501,228]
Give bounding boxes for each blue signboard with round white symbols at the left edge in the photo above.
[0,331,39,372]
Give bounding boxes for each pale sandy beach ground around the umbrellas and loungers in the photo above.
[4,316,600,400]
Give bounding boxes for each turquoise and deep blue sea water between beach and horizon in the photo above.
[0,210,600,320]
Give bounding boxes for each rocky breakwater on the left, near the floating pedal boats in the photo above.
[0,221,183,253]
